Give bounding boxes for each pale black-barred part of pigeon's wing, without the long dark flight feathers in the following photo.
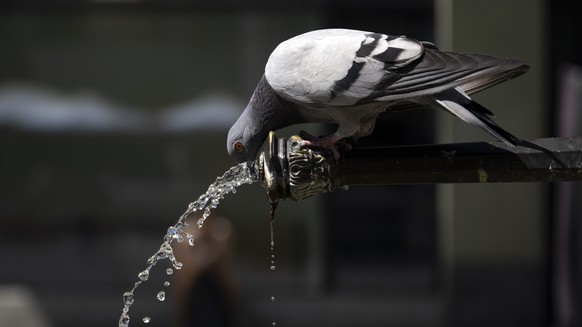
[265,29,423,107]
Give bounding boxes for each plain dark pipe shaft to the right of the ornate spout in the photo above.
[335,137,582,185]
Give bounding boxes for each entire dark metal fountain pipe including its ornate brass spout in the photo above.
[259,132,582,203]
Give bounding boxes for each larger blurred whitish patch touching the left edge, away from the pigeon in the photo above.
[0,84,145,132]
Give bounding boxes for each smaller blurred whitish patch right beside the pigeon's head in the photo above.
[158,94,244,132]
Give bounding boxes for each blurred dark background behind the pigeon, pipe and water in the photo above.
[0,0,582,327]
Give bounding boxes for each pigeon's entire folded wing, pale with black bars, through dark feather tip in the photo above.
[265,29,528,107]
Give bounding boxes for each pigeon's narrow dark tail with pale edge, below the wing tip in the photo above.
[431,88,520,146]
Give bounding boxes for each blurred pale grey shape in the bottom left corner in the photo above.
[0,285,49,327]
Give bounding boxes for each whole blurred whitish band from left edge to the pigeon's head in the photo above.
[0,84,244,133]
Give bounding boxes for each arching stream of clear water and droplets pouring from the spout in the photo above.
[119,162,259,327]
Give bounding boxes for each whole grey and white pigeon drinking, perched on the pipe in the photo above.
[227,29,529,162]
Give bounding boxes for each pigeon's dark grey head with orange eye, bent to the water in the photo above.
[226,107,268,163]
